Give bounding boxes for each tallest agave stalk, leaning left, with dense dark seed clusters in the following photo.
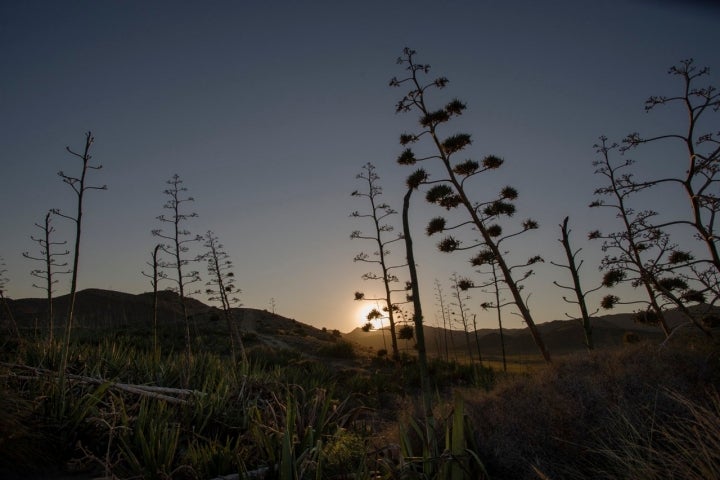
[390,48,551,362]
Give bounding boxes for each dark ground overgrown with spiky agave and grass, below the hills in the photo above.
[0,292,720,480]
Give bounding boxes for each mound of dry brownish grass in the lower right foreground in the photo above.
[466,344,720,479]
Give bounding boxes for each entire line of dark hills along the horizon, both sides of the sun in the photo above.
[0,288,716,355]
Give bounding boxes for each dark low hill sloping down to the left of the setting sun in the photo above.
[5,289,374,362]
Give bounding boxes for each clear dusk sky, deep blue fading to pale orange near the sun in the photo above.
[0,0,720,332]
